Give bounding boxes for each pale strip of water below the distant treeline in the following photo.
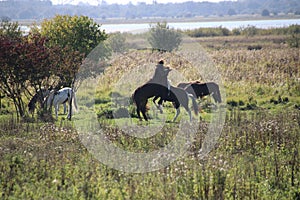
[21,19,300,33]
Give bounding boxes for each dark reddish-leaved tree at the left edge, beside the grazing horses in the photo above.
[0,25,81,117]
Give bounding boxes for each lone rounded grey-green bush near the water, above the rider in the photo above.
[148,22,182,52]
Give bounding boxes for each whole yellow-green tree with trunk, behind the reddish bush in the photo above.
[40,15,110,87]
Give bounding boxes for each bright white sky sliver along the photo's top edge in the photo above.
[50,0,237,6]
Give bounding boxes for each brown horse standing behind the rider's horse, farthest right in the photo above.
[177,81,222,103]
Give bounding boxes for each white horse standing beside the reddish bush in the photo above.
[47,87,77,119]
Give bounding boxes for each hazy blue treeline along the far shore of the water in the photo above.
[0,0,300,20]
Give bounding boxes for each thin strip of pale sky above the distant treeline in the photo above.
[51,0,234,5]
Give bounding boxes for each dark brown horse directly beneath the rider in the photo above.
[132,82,198,122]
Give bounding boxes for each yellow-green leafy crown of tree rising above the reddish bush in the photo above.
[41,15,107,56]
